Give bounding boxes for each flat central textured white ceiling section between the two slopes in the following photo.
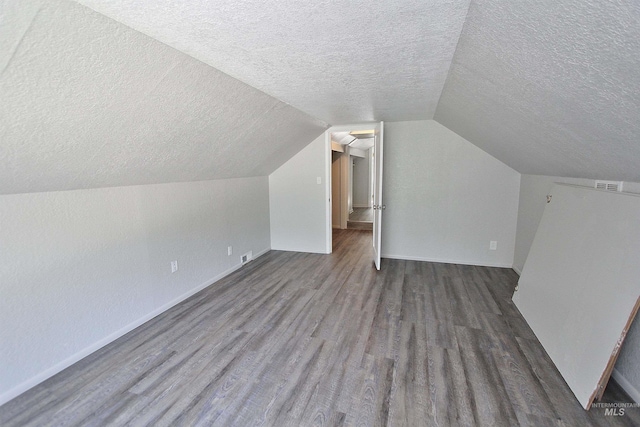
[74,0,469,124]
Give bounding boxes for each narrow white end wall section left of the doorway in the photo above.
[269,134,330,253]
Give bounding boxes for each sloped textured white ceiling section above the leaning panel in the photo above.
[435,0,640,181]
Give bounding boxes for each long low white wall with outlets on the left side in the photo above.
[0,177,270,404]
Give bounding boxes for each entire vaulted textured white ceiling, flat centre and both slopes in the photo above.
[0,0,640,194]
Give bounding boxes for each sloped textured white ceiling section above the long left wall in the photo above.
[0,0,327,194]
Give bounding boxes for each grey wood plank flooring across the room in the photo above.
[0,230,640,426]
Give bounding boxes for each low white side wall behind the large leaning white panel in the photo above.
[513,175,640,401]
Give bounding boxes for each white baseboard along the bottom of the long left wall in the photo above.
[0,248,271,405]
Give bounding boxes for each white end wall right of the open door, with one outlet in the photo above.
[382,120,520,267]
